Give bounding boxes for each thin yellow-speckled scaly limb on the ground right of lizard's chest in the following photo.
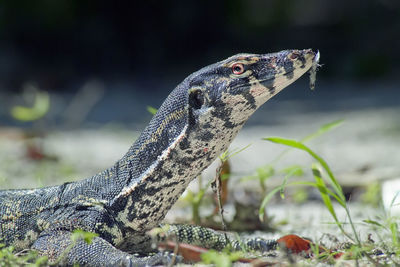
[159,224,277,251]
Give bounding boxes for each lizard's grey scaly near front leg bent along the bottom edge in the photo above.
[32,231,178,266]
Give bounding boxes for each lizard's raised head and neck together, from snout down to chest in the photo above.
[111,49,318,232]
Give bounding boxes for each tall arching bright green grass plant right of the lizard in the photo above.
[259,137,400,266]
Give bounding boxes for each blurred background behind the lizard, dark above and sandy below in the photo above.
[0,0,400,209]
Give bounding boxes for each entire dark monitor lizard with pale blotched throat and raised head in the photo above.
[0,49,317,266]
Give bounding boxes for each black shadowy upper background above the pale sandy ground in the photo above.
[0,0,400,126]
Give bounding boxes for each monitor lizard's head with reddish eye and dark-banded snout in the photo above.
[187,49,319,128]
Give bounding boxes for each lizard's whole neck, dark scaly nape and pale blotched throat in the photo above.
[109,87,244,232]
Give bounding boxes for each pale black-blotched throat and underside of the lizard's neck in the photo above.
[111,119,239,232]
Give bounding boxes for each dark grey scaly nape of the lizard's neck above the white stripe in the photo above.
[72,85,188,205]
